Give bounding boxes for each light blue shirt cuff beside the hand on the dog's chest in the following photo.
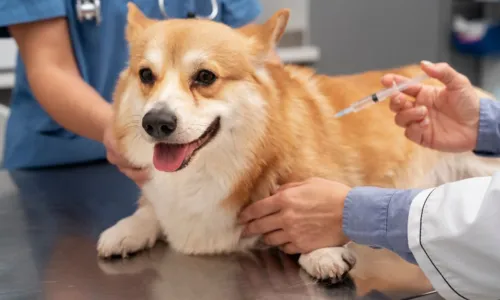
[342,187,421,263]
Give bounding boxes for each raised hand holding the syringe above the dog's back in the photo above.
[382,62,479,152]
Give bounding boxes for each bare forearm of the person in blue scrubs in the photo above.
[9,18,112,141]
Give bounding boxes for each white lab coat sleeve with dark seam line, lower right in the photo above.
[408,173,500,300]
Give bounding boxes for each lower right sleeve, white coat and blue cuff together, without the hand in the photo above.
[343,174,500,299]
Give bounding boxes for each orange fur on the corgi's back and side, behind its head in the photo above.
[223,65,446,206]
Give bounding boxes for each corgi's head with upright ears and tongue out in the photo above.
[114,3,289,172]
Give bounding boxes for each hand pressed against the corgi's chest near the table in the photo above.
[240,178,350,254]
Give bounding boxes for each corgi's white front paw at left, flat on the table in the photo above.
[97,215,159,257]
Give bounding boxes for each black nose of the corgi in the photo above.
[142,109,177,139]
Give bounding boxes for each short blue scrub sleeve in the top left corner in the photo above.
[0,0,67,32]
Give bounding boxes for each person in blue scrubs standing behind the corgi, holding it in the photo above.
[0,0,261,183]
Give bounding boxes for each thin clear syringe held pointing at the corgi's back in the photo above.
[335,74,429,118]
